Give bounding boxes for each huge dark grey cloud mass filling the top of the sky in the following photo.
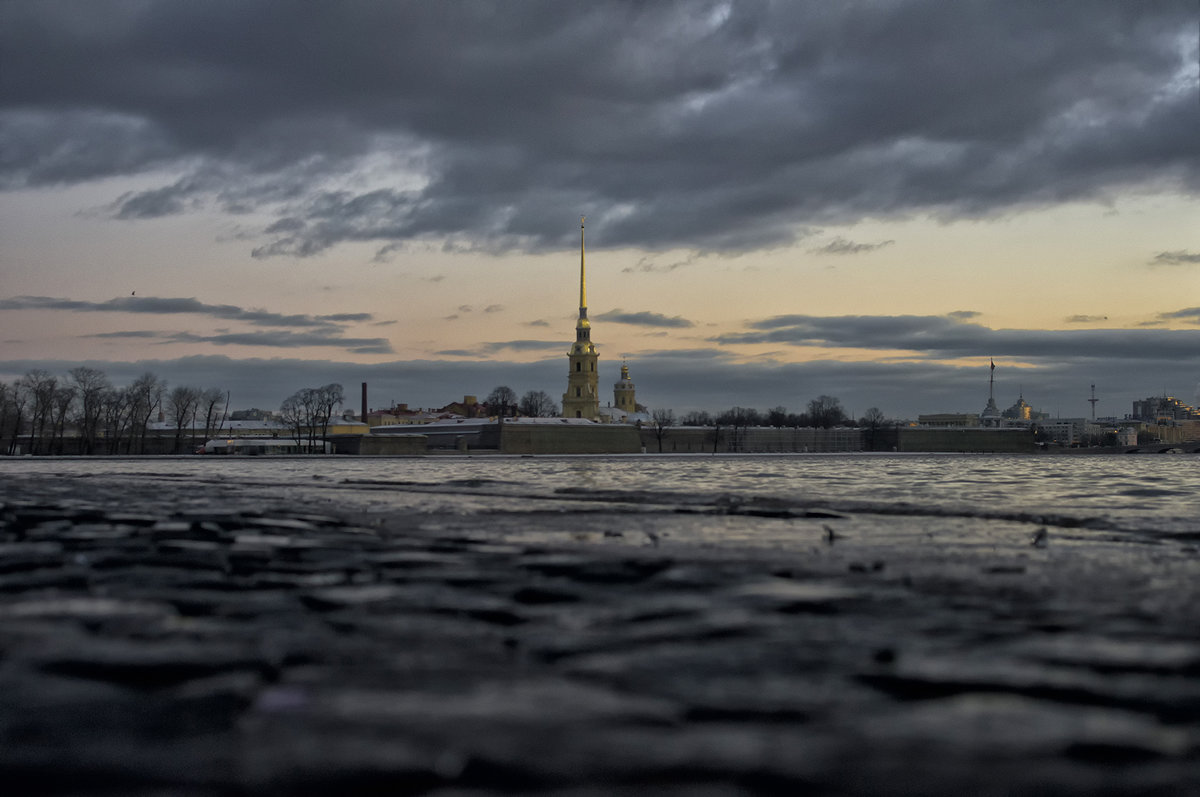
[0,0,1200,256]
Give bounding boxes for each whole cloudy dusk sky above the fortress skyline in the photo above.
[0,0,1200,418]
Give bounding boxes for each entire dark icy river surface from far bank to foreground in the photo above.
[0,457,1200,795]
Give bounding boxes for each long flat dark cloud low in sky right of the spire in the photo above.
[710,310,1200,361]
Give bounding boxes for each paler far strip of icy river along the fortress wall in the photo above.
[0,454,1200,535]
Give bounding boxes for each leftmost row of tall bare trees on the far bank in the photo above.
[0,367,228,455]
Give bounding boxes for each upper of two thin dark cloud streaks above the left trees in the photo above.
[0,296,373,330]
